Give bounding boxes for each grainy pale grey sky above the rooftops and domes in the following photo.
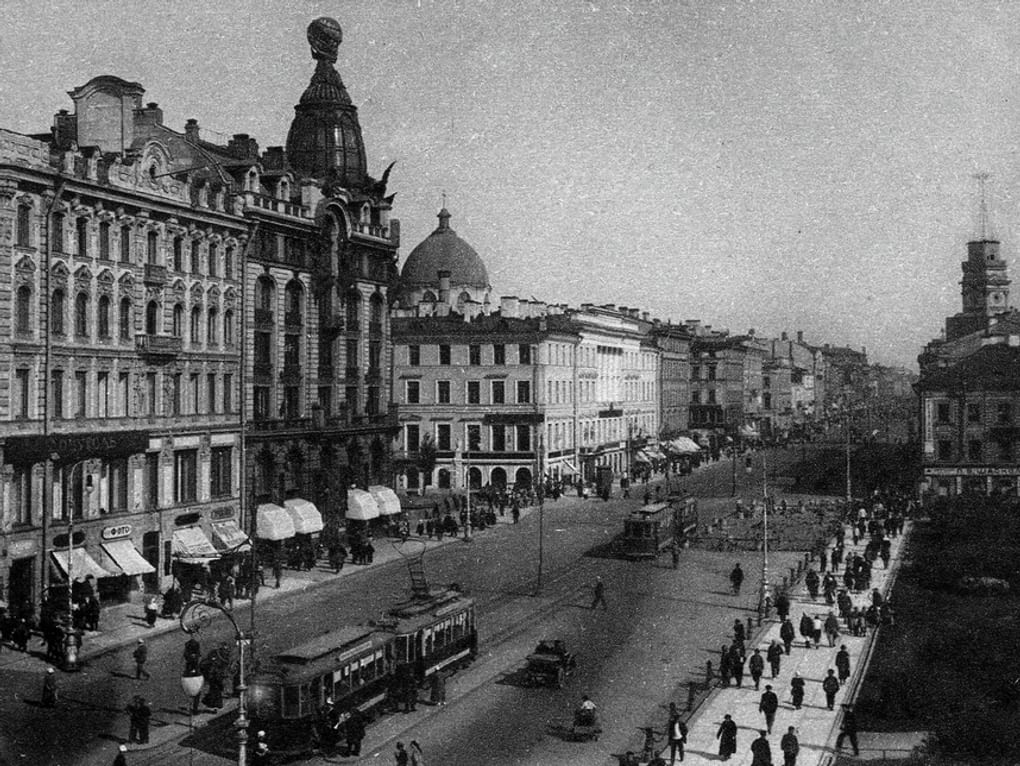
[0,0,1020,365]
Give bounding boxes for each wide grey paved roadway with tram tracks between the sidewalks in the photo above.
[0,446,820,766]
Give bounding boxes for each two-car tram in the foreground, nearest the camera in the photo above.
[249,590,477,750]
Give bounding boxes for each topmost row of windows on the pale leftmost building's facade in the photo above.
[14,204,235,279]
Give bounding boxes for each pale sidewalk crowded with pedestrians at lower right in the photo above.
[660,522,910,766]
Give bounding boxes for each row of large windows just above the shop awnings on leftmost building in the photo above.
[9,447,234,525]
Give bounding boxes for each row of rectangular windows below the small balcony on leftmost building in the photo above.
[11,367,235,420]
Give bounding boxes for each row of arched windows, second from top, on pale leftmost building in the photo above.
[14,285,235,346]
